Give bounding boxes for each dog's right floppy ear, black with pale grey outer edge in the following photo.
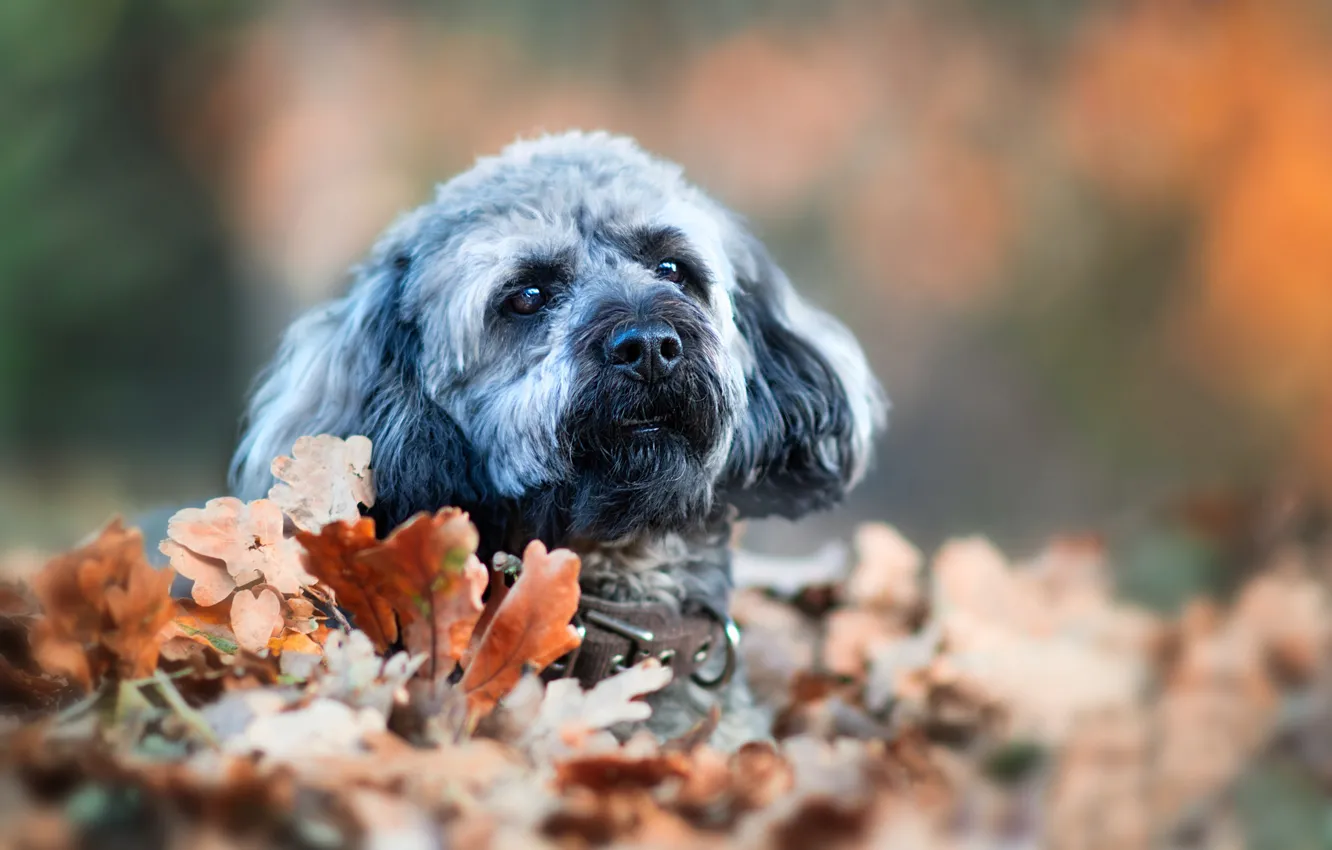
[719,230,887,518]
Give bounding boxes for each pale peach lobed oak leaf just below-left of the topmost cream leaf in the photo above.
[160,497,310,596]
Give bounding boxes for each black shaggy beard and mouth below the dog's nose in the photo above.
[561,364,729,541]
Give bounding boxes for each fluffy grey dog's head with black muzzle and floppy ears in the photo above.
[232,133,884,542]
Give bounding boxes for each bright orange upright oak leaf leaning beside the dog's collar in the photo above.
[461,540,581,726]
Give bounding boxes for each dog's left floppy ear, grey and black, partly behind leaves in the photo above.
[230,242,490,533]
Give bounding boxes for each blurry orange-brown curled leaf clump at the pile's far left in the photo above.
[32,518,176,690]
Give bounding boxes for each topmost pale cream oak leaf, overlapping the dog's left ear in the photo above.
[268,434,374,533]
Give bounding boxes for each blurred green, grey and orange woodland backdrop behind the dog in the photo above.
[0,0,1332,605]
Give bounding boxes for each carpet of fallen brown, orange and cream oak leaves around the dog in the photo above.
[0,436,1332,849]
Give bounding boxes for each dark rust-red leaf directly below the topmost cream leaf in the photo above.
[296,517,398,653]
